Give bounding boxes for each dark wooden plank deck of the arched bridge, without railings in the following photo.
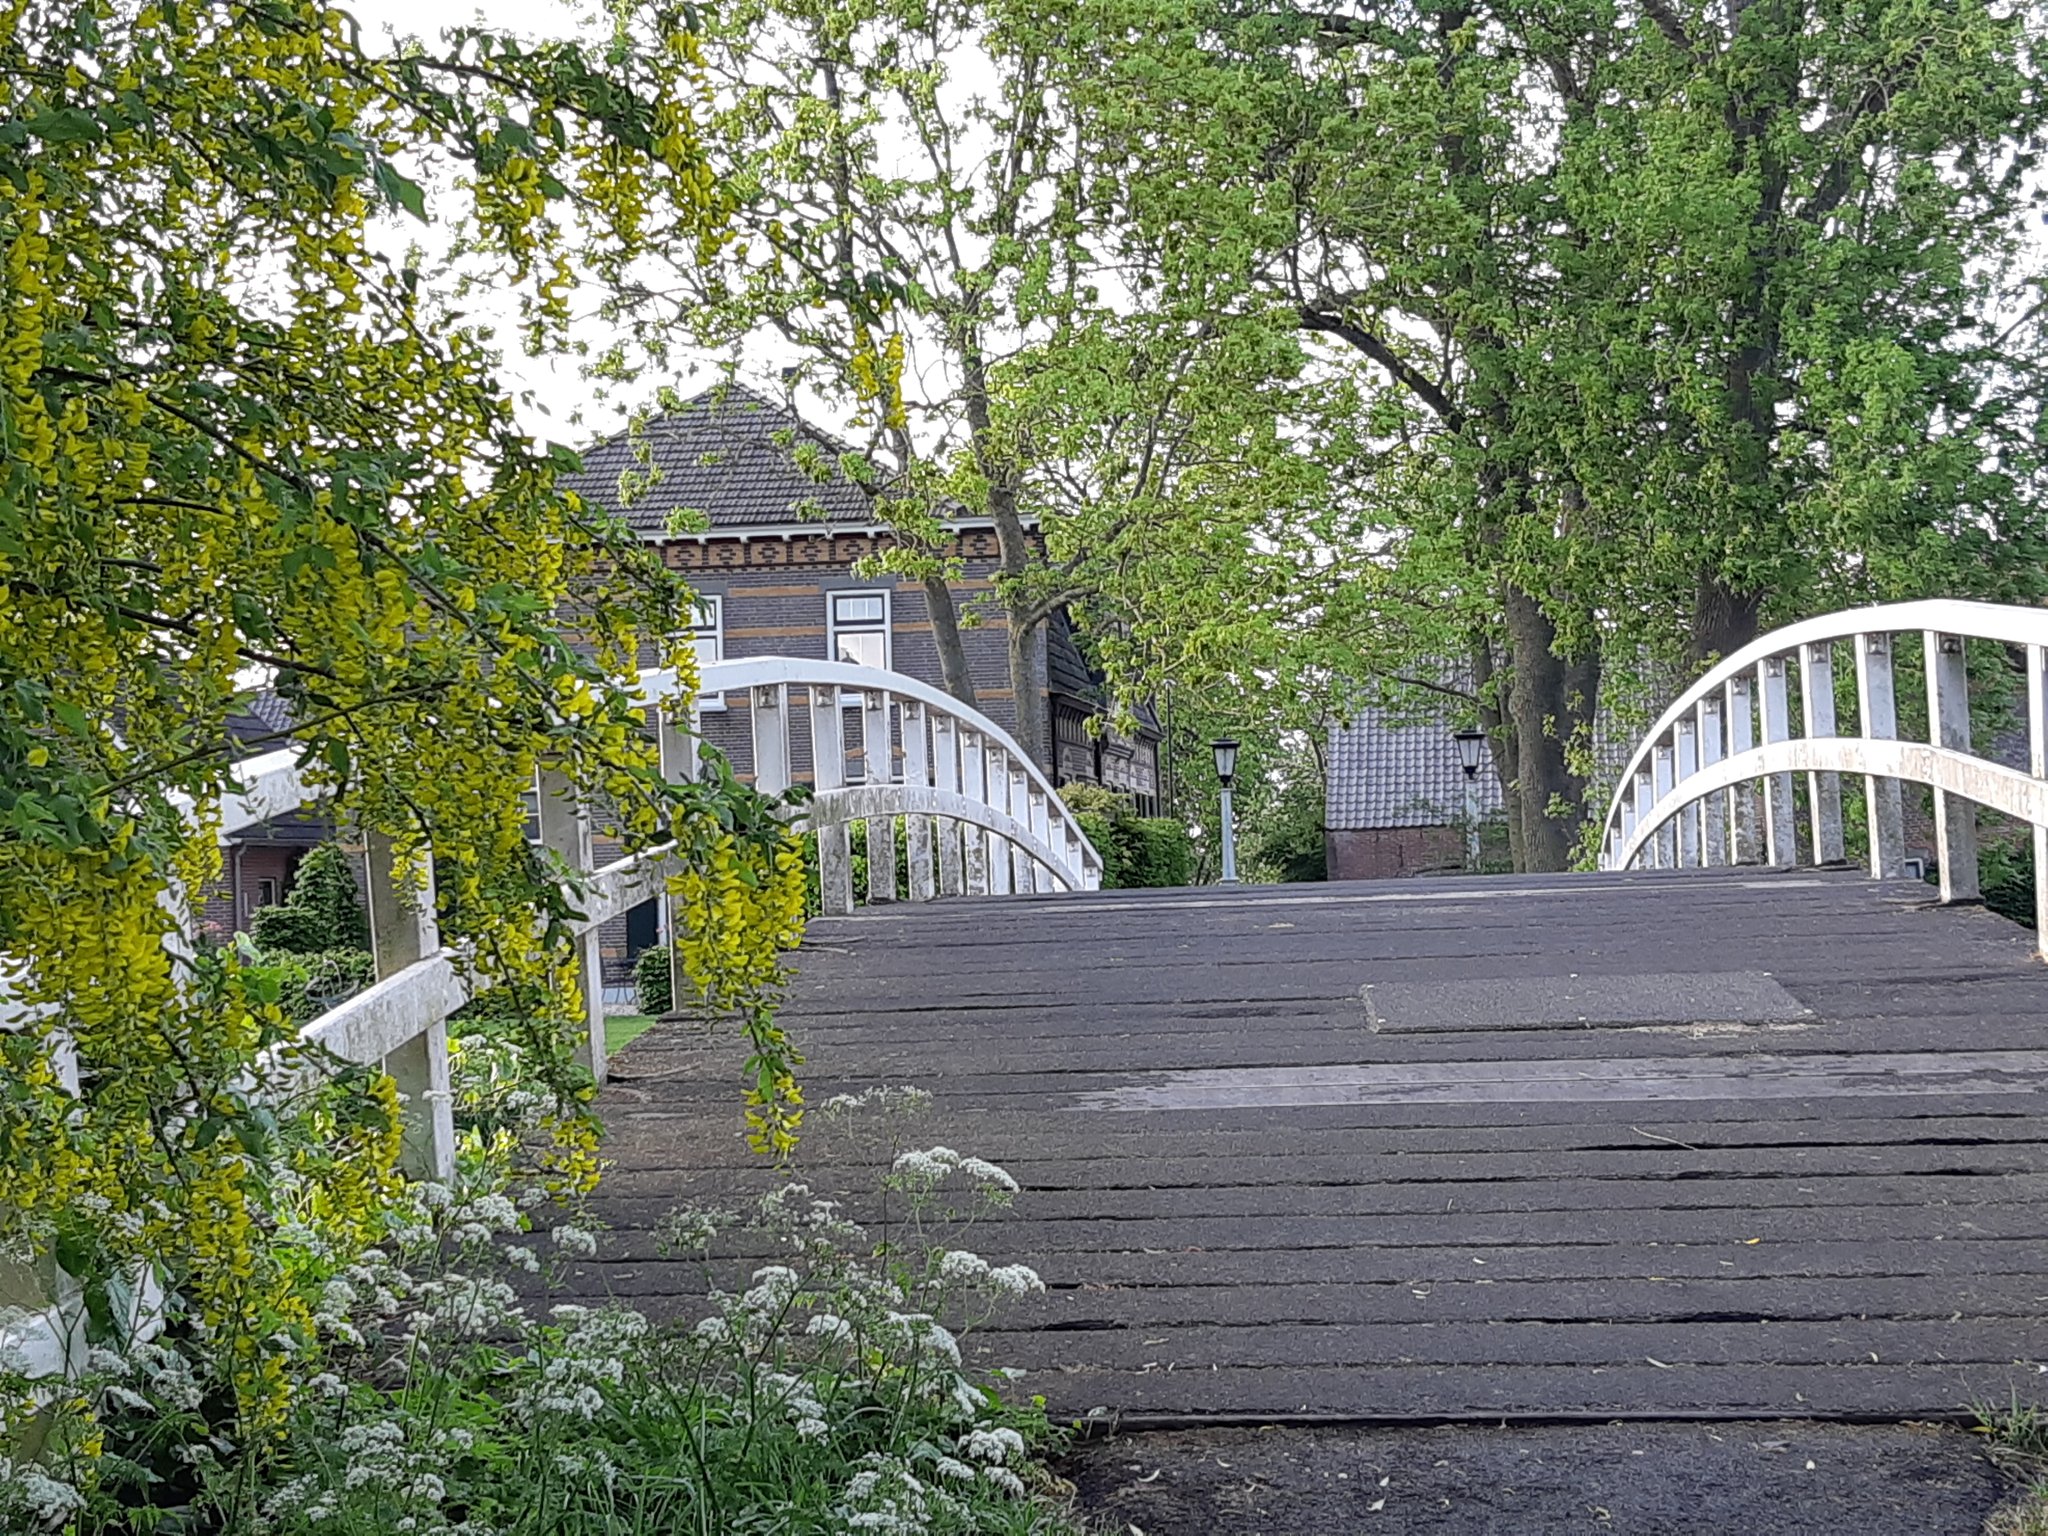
[575,870,2048,1421]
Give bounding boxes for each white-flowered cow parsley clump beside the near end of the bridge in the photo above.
[36,1105,1081,1536]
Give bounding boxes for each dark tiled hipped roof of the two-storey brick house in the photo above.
[563,383,877,535]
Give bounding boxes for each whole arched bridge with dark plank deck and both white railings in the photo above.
[19,604,2048,1423]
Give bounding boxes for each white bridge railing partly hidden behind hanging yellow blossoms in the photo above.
[0,655,1102,1374]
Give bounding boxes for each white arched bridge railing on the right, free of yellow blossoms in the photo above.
[1599,602,2048,950]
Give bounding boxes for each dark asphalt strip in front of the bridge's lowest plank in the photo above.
[1065,1421,2005,1536]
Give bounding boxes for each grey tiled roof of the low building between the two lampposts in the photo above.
[1323,709,1501,831]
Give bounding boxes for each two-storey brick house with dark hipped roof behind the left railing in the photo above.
[567,383,1159,991]
